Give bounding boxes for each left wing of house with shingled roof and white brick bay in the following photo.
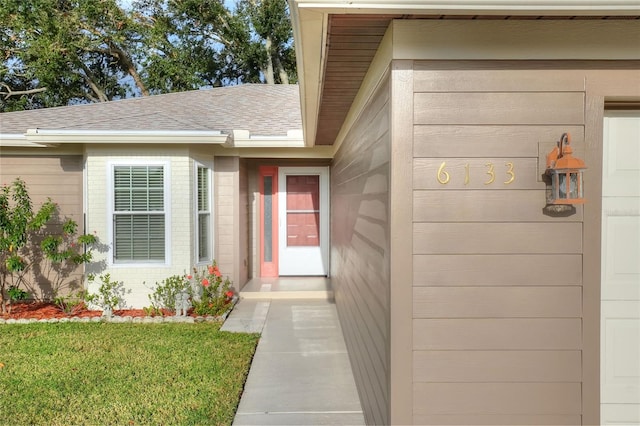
[0,85,310,308]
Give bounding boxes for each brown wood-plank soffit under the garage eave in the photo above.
[315,15,640,145]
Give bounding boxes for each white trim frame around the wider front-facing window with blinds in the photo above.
[107,160,172,268]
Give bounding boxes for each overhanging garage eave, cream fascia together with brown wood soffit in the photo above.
[290,0,640,146]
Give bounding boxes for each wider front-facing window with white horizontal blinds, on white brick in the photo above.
[113,165,166,263]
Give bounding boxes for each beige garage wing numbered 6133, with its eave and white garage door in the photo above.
[292,0,640,425]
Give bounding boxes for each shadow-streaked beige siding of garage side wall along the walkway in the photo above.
[331,75,390,424]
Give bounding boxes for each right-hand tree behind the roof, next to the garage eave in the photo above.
[140,0,297,89]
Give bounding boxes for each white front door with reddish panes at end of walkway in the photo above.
[278,167,329,276]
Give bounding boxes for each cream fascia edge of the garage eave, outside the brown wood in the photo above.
[288,0,640,146]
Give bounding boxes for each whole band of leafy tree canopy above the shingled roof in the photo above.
[0,0,297,111]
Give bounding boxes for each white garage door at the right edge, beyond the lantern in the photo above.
[600,111,640,425]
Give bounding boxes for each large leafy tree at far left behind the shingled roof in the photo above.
[0,0,148,111]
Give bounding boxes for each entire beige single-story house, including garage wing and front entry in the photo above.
[0,0,640,425]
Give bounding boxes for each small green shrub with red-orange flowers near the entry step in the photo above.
[192,260,234,315]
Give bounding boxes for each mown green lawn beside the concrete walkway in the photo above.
[0,323,258,426]
